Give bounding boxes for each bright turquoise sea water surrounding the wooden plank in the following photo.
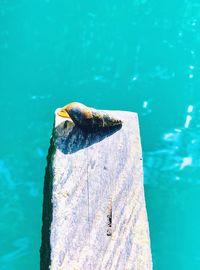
[0,0,200,270]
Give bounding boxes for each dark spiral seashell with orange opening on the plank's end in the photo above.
[58,102,122,130]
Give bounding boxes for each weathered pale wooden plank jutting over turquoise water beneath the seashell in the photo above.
[41,108,152,270]
